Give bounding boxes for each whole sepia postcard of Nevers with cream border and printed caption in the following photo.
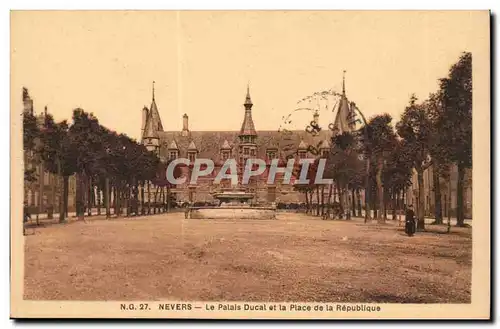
[10,11,491,319]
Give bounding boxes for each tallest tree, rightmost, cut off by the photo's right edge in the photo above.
[438,52,472,226]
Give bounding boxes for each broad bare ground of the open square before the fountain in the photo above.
[24,213,472,303]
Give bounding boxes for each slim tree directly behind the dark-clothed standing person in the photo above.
[396,95,432,230]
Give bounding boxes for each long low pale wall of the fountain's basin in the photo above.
[190,207,276,219]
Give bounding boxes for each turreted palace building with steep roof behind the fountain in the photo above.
[141,84,352,204]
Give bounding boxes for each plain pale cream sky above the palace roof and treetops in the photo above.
[11,11,489,139]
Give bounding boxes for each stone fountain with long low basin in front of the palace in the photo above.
[190,185,276,219]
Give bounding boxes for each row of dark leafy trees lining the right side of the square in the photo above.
[296,53,472,229]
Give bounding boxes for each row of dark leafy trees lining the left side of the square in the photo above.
[23,104,180,221]
